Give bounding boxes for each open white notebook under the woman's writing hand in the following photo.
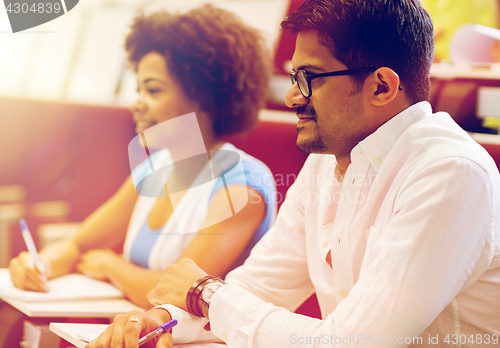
[0,269,123,302]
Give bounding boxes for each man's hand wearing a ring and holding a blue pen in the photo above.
[85,309,173,348]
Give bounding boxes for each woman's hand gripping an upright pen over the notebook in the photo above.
[9,251,49,292]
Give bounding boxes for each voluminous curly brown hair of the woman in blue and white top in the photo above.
[125,5,270,137]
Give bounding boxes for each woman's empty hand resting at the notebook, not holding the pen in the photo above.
[76,249,122,281]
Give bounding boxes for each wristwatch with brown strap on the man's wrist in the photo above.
[186,276,226,319]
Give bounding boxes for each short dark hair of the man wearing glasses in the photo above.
[281,0,434,103]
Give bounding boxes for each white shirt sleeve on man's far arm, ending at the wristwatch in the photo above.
[226,164,314,311]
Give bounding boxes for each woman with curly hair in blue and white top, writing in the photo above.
[9,6,276,308]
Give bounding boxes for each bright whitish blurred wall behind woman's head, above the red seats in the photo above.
[0,0,289,105]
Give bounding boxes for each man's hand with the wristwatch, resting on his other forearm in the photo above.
[148,259,207,310]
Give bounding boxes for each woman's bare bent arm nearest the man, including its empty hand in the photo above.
[78,185,266,308]
